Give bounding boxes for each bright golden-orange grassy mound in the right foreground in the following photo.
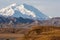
[26,26,60,40]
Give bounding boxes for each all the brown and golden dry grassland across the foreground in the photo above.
[0,26,60,40]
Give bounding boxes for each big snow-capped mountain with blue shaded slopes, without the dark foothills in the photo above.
[0,3,49,20]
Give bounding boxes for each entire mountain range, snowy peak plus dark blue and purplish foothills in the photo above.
[0,3,60,26]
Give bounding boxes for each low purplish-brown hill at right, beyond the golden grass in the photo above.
[42,17,60,27]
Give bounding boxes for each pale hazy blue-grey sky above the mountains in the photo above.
[0,0,60,17]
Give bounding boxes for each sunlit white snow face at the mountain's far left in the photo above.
[0,4,16,16]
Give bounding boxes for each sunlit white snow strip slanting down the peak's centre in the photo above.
[17,5,36,17]
